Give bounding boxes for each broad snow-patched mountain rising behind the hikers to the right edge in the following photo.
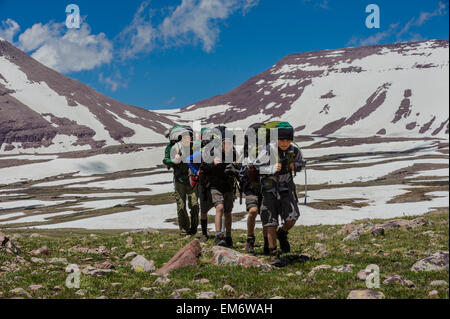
[163,40,449,138]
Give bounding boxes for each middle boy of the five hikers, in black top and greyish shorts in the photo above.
[201,126,237,247]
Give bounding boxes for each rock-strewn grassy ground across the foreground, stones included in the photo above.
[0,209,449,299]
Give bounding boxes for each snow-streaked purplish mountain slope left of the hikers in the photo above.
[0,40,174,153]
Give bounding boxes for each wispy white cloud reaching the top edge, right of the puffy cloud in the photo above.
[118,0,259,60]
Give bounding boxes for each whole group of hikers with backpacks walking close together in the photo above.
[163,121,306,266]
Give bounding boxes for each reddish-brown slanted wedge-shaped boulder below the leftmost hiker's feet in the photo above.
[155,239,202,275]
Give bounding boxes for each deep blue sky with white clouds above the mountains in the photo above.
[0,0,449,109]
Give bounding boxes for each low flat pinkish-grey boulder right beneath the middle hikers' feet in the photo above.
[212,246,272,270]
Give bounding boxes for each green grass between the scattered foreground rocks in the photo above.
[0,208,449,299]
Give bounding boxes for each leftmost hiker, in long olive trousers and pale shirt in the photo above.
[163,126,199,235]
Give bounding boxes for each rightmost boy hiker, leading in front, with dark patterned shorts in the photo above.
[257,122,304,266]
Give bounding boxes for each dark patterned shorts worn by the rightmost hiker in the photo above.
[261,191,300,226]
